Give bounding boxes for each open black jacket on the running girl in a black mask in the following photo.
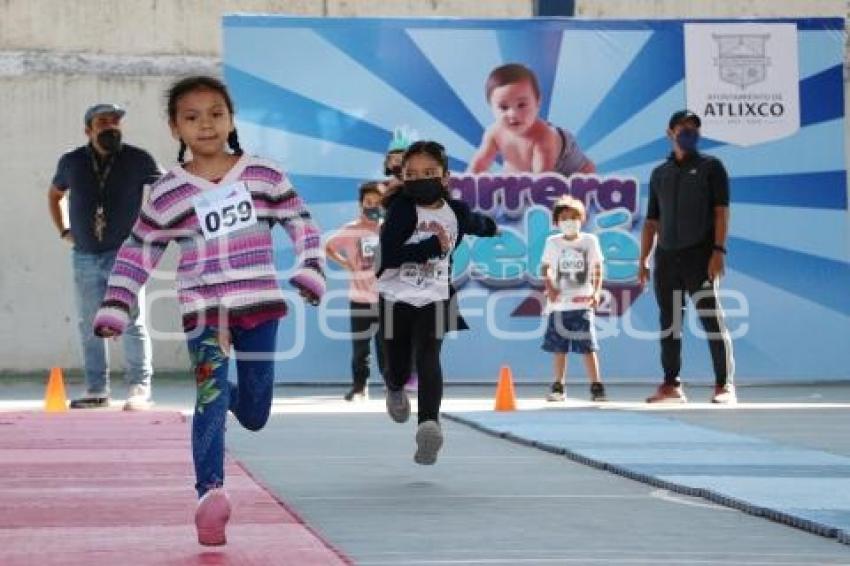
[377,193,498,332]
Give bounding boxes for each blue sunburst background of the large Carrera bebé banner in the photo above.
[224,16,850,381]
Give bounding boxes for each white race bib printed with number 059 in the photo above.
[193,183,257,240]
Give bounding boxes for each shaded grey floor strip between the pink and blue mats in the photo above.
[230,414,850,565]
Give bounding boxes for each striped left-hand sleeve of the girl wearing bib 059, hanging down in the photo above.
[92,198,173,337]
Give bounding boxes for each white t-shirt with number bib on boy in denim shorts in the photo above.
[542,232,603,313]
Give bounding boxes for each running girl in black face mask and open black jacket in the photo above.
[377,141,497,465]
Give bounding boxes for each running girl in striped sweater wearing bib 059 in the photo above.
[94,77,325,545]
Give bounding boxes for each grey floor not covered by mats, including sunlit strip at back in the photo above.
[0,376,850,565]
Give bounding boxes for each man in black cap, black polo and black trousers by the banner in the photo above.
[639,110,737,403]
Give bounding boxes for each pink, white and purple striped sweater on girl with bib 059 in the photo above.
[94,156,325,333]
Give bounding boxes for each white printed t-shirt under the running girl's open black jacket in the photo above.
[378,202,458,307]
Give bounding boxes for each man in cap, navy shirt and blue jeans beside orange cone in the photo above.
[48,104,160,410]
